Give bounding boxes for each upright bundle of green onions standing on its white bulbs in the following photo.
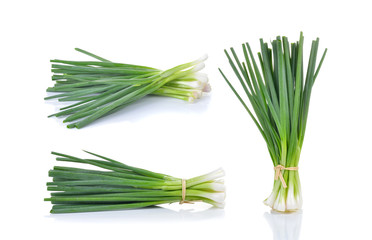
[219,33,327,212]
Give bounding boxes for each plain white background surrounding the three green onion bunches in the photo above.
[0,0,372,240]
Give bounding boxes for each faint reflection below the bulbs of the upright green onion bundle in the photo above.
[264,211,302,240]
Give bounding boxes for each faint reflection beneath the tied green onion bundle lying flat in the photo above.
[47,204,225,223]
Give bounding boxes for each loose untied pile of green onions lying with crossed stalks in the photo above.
[45,48,210,128]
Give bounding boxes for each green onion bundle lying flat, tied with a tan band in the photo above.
[44,152,225,213]
